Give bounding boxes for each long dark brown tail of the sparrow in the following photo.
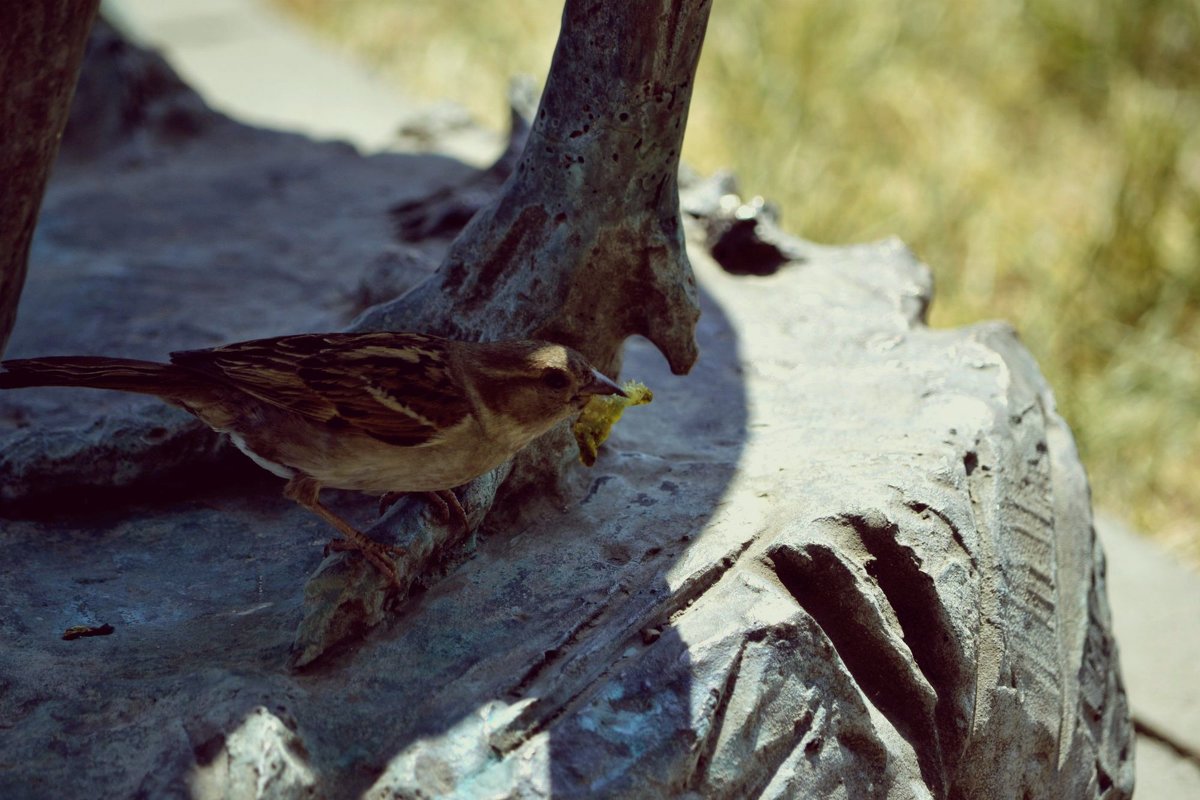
[0,355,200,397]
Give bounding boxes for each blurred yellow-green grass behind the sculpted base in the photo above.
[272,0,1200,565]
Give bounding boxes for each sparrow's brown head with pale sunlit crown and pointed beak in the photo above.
[465,341,625,439]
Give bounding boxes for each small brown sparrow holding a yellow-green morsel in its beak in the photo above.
[0,333,624,582]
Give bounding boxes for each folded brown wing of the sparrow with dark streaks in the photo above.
[172,333,470,447]
